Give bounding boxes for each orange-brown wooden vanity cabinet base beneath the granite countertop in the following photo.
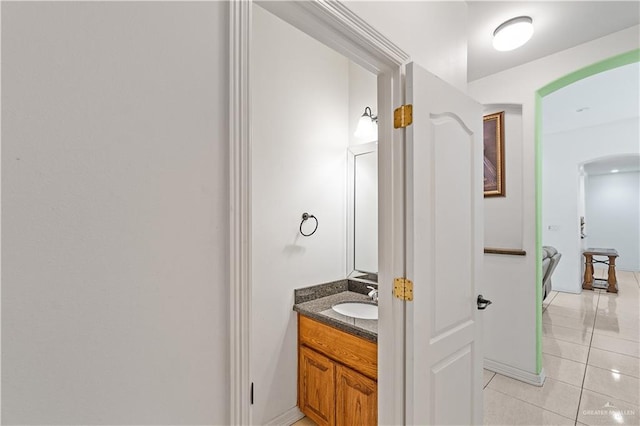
[298,315,378,426]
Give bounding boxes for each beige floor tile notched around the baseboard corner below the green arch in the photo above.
[487,374,580,418]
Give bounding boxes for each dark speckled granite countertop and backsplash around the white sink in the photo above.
[293,280,378,343]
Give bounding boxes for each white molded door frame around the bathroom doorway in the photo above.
[229,0,409,425]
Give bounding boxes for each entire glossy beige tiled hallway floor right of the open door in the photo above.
[484,270,640,425]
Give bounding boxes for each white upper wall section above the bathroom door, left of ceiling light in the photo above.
[345,0,467,92]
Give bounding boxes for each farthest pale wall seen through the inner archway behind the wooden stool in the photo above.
[585,171,640,271]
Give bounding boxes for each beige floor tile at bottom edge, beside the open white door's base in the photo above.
[484,389,575,426]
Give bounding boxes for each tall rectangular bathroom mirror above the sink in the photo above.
[347,142,378,282]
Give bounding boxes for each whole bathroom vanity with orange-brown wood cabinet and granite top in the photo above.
[294,280,378,425]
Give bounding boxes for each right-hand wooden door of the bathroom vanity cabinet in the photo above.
[336,365,378,426]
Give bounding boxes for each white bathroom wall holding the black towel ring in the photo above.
[251,7,350,424]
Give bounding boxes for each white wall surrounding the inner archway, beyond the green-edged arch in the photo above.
[542,119,640,293]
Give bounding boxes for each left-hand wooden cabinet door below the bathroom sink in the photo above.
[298,346,336,426]
